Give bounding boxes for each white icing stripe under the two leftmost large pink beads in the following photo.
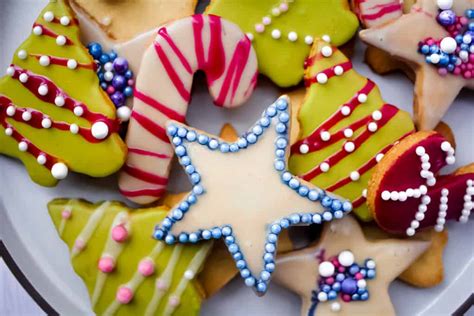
[91,211,131,306]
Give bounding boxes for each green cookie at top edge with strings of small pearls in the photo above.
[206,0,358,87]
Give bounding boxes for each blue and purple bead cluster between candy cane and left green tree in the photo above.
[87,42,135,121]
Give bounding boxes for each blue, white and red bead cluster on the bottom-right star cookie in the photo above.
[312,250,375,311]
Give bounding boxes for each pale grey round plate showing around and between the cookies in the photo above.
[0,0,474,315]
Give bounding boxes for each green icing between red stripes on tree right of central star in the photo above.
[289,42,414,220]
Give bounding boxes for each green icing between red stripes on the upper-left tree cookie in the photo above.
[0,0,126,186]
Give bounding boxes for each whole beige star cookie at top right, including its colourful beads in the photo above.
[360,0,474,130]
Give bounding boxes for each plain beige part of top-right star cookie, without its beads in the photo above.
[360,0,474,130]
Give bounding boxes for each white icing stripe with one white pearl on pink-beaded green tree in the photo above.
[163,242,212,315]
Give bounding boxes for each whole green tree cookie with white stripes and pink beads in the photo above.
[48,199,212,315]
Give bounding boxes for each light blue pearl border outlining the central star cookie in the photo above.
[154,97,352,294]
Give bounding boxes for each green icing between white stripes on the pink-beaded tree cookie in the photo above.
[48,199,205,315]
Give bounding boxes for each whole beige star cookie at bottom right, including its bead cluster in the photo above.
[275,216,429,316]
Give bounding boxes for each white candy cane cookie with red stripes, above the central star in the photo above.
[119,15,258,204]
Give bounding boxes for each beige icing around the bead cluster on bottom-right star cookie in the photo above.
[274,216,429,316]
